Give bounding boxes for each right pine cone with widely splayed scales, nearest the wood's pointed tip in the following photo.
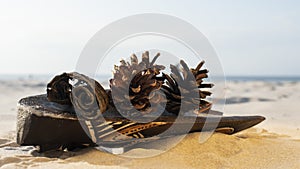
[162,60,213,114]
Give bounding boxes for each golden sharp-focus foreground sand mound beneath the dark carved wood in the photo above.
[0,129,300,169]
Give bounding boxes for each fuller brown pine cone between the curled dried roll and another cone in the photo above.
[110,51,166,116]
